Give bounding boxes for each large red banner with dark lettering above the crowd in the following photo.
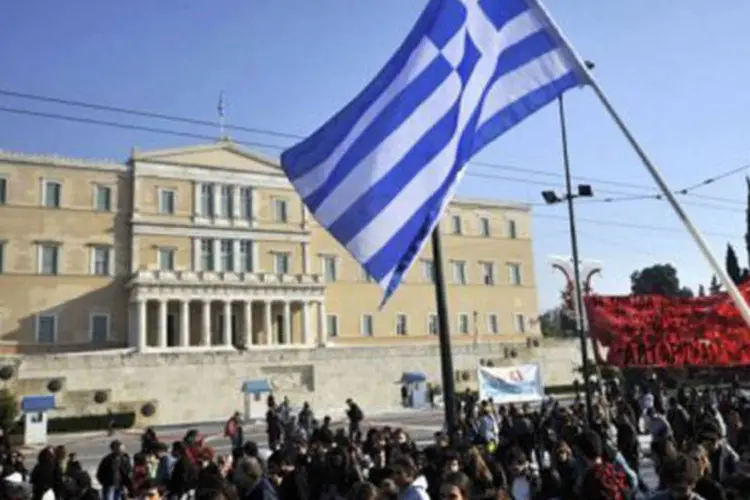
[586,284,750,367]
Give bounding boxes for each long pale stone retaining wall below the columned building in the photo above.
[5,341,580,425]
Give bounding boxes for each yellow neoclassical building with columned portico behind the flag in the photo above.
[0,140,539,353]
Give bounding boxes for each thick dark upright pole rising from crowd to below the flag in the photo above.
[432,224,458,444]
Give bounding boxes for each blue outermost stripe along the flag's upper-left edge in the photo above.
[282,0,442,179]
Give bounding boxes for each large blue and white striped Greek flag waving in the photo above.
[281,0,587,302]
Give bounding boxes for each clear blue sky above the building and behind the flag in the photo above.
[0,0,750,308]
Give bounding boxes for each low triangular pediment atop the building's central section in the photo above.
[132,140,284,177]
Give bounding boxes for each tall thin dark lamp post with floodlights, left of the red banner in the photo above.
[557,95,594,428]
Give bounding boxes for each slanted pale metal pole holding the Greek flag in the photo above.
[529,0,750,334]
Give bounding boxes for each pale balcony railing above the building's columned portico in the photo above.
[130,269,325,286]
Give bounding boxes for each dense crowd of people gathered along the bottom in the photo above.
[0,382,750,500]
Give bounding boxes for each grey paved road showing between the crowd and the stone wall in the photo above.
[38,410,657,488]
